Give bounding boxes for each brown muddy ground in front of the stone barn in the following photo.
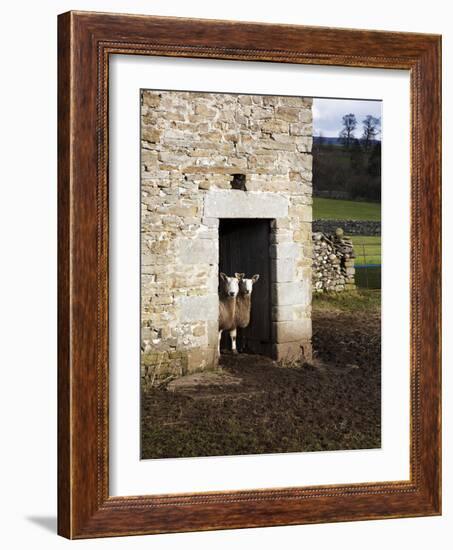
[142,293,381,458]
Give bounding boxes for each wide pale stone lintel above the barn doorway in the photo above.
[204,189,288,218]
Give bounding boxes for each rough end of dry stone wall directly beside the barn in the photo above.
[313,229,355,293]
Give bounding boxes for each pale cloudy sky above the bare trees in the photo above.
[313,98,382,138]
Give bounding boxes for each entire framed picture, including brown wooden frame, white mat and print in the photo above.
[58,11,441,539]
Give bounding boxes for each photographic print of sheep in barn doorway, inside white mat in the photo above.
[140,89,382,459]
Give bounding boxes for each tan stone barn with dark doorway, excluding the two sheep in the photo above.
[141,90,312,385]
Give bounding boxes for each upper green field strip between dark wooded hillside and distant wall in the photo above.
[313,197,381,221]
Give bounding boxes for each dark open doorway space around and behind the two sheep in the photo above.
[219,220,271,355]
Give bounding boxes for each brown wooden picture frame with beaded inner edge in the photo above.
[58,12,441,538]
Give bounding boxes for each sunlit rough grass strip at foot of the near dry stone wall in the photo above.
[312,288,381,313]
